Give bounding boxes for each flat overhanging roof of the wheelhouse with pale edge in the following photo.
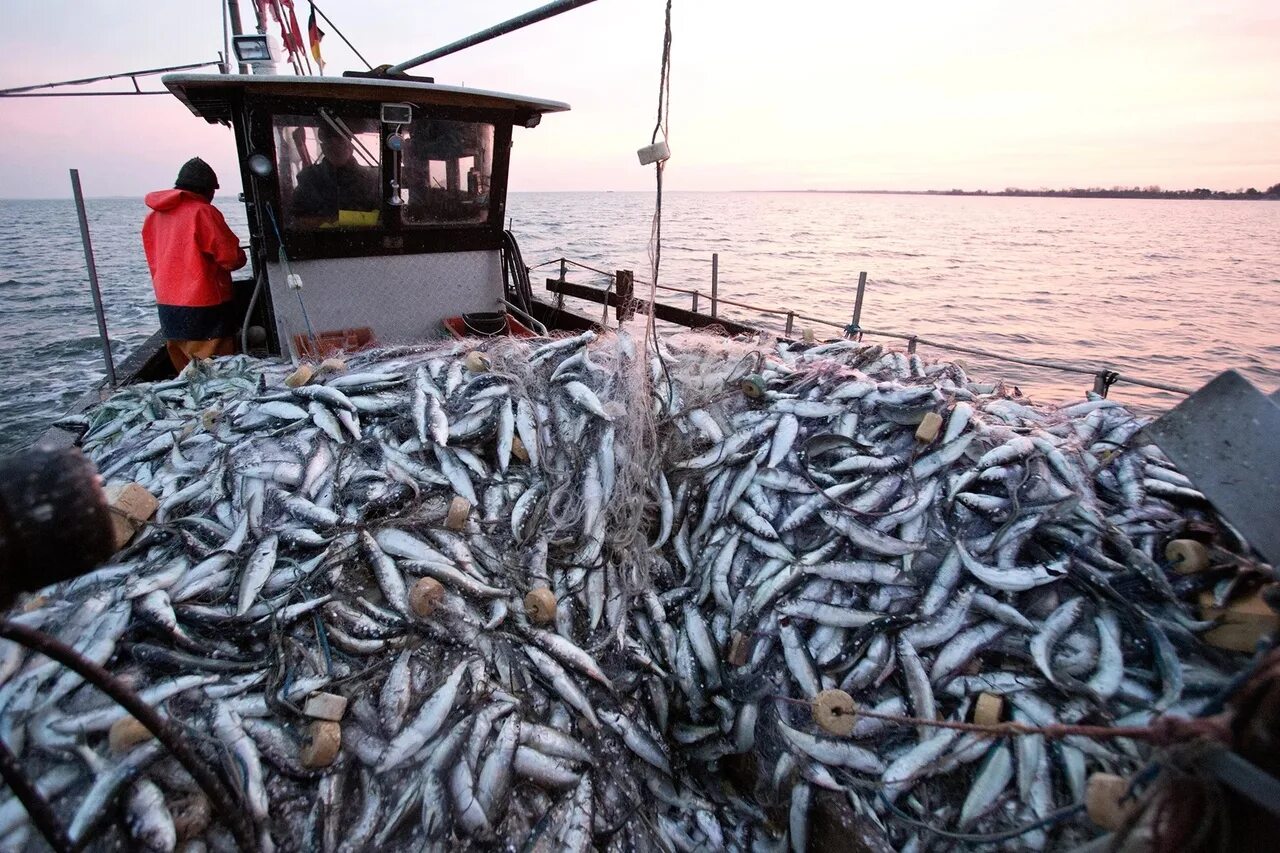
[160,74,568,124]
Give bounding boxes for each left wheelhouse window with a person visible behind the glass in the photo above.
[274,110,381,232]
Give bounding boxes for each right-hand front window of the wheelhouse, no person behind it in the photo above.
[399,117,494,225]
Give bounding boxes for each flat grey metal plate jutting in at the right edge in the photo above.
[1143,370,1280,565]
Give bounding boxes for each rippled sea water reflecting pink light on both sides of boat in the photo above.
[0,192,1280,450]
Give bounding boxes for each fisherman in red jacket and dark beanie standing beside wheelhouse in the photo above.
[142,158,247,370]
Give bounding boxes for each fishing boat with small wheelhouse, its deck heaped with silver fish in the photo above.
[0,3,1274,850]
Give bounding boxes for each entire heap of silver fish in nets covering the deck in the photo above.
[0,326,1243,850]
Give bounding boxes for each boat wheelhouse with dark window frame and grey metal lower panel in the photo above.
[164,74,568,357]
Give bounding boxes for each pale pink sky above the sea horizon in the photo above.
[0,0,1280,197]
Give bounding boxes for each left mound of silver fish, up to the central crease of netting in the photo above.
[10,334,760,850]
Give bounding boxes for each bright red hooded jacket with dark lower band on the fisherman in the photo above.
[142,190,246,341]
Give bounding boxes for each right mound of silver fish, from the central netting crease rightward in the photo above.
[645,341,1247,849]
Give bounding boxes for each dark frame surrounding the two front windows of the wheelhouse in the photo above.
[242,92,518,260]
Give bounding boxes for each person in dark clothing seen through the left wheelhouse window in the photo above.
[289,122,379,228]
